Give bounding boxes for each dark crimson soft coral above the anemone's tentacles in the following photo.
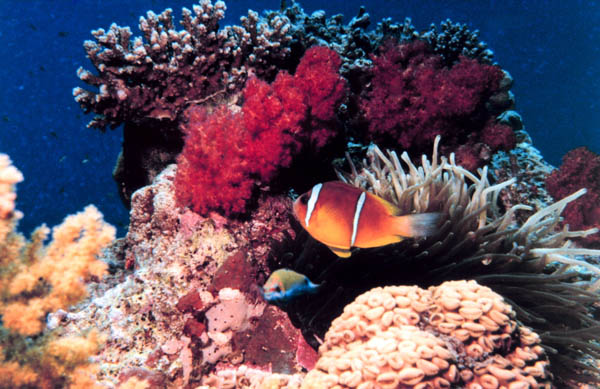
[360,41,515,169]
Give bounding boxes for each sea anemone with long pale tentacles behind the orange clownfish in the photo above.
[282,137,600,385]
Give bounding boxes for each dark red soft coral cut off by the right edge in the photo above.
[546,147,600,248]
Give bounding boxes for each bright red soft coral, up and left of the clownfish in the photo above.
[175,47,346,215]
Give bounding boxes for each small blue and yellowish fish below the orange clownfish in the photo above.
[263,269,320,303]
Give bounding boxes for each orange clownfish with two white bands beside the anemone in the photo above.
[294,181,440,258]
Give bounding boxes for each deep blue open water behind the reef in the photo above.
[0,0,600,235]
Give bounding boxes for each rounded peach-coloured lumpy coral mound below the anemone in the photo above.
[303,281,551,389]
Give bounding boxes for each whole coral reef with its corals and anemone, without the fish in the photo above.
[57,0,600,389]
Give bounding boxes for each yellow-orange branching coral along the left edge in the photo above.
[0,155,115,388]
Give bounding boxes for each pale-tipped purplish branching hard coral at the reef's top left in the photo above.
[73,0,291,129]
